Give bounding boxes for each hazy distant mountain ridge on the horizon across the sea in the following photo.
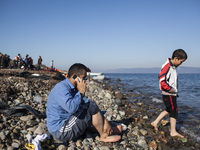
[104,66,200,73]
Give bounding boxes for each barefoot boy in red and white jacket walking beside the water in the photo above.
[151,49,187,138]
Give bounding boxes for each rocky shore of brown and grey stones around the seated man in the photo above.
[0,69,200,150]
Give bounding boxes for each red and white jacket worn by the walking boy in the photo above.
[158,58,178,96]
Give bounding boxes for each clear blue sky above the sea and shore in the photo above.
[0,0,200,72]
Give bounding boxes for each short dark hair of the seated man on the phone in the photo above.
[67,63,89,78]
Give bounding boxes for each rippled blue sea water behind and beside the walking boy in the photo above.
[105,73,200,142]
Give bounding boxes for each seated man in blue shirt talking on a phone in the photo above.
[46,63,122,142]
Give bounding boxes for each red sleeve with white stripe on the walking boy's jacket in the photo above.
[158,64,172,92]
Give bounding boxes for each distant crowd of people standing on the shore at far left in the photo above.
[0,53,42,70]
